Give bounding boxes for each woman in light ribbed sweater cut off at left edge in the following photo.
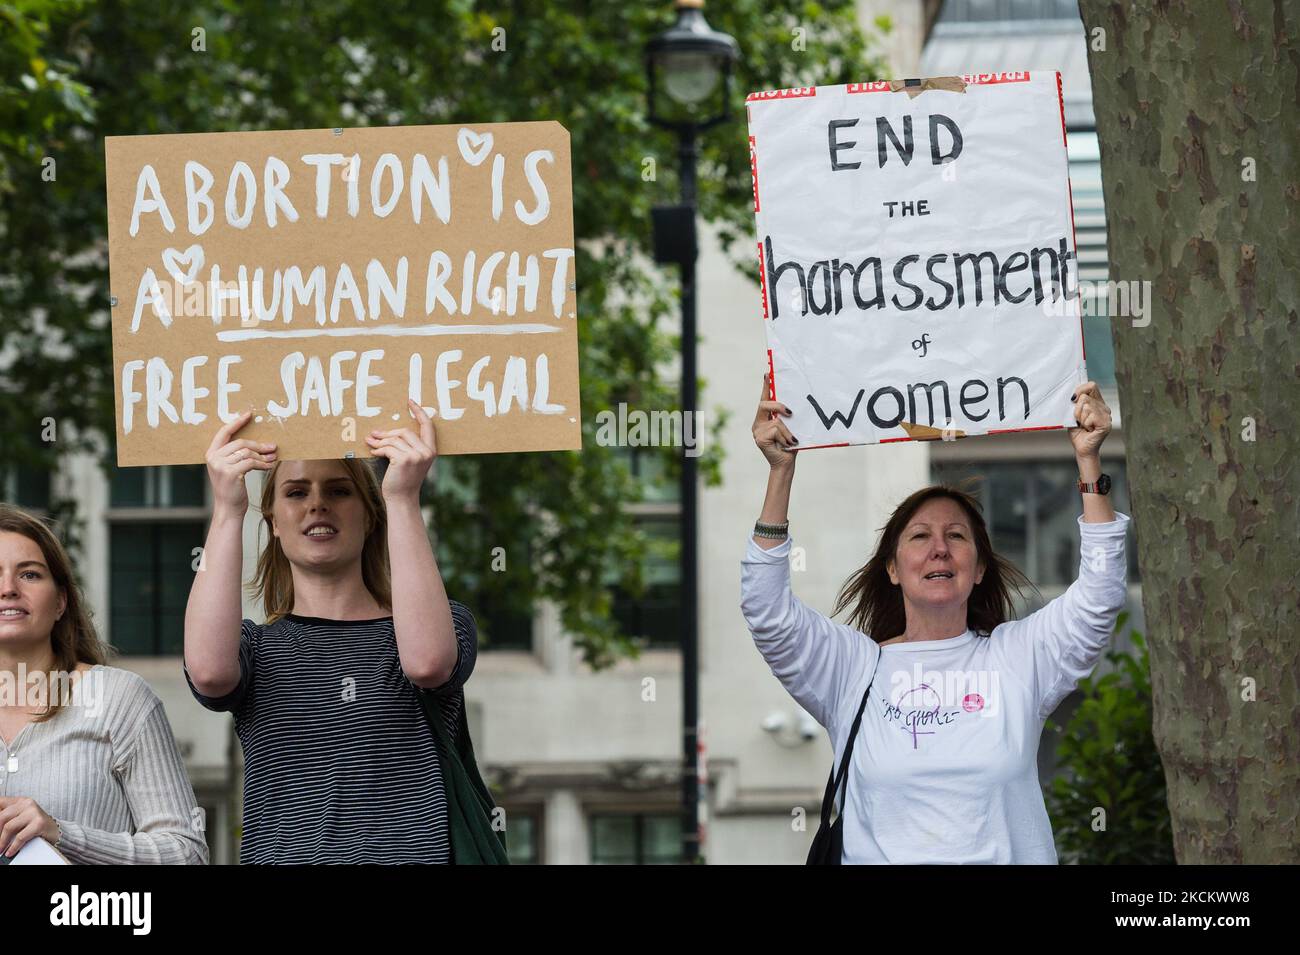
[0,504,208,865]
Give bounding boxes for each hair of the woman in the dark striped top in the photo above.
[252,457,393,624]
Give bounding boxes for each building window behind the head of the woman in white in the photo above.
[930,460,1139,590]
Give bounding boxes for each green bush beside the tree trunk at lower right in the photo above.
[1047,613,1174,865]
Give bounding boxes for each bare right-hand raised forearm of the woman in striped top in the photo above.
[365,401,463,690]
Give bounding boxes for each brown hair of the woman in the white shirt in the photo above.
[835,485,1034,643]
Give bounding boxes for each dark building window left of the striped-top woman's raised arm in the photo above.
[108,465,207,656]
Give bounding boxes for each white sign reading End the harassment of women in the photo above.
[748,73,1087,450]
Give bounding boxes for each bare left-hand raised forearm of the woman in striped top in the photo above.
[185,412,276,698]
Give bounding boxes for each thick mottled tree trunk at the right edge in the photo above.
[1079,0,1300,863]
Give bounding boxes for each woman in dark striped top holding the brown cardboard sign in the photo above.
[185,401,504,863]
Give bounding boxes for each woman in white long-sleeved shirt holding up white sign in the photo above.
[741,377,1128,864]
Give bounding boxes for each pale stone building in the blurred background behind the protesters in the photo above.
[12,0,1141,863]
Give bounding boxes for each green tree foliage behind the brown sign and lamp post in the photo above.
[0,0,878,665]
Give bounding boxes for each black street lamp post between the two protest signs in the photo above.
[645,0,740,863]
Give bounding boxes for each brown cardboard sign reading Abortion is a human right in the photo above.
[104,122,581,465]
